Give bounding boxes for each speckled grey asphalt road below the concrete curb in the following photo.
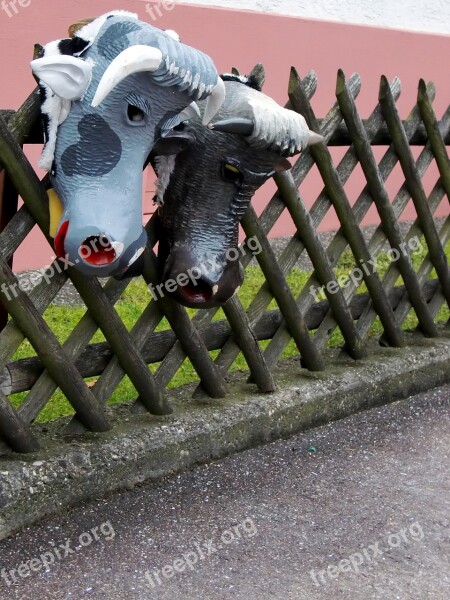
[0,387,450,600]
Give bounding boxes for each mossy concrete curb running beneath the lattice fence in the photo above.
[0,338,450,539]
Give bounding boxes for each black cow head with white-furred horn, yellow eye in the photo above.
[153,65,322,308]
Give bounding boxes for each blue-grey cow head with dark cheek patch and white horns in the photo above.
[31,11,224,276]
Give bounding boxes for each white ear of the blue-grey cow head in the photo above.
[31,54,92,100]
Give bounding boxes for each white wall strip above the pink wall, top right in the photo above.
[175,0,450,34]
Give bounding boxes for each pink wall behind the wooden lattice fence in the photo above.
[0,0,450,271]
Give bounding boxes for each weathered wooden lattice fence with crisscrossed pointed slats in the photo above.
[0,69,450,452]
